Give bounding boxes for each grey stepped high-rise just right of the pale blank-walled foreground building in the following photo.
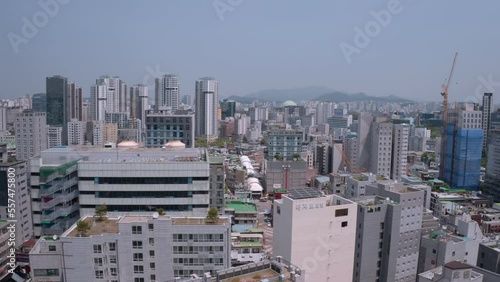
[353,183,424,282]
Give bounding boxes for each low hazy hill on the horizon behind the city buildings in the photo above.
[226,86,413,104]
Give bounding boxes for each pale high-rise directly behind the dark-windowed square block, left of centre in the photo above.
[155,74,179,111]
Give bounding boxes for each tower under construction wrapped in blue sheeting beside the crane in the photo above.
[441,103,483,190]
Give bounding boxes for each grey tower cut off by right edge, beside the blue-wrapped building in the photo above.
[484,128,500,199]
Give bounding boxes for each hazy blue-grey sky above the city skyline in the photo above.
[0,0,500,101]
